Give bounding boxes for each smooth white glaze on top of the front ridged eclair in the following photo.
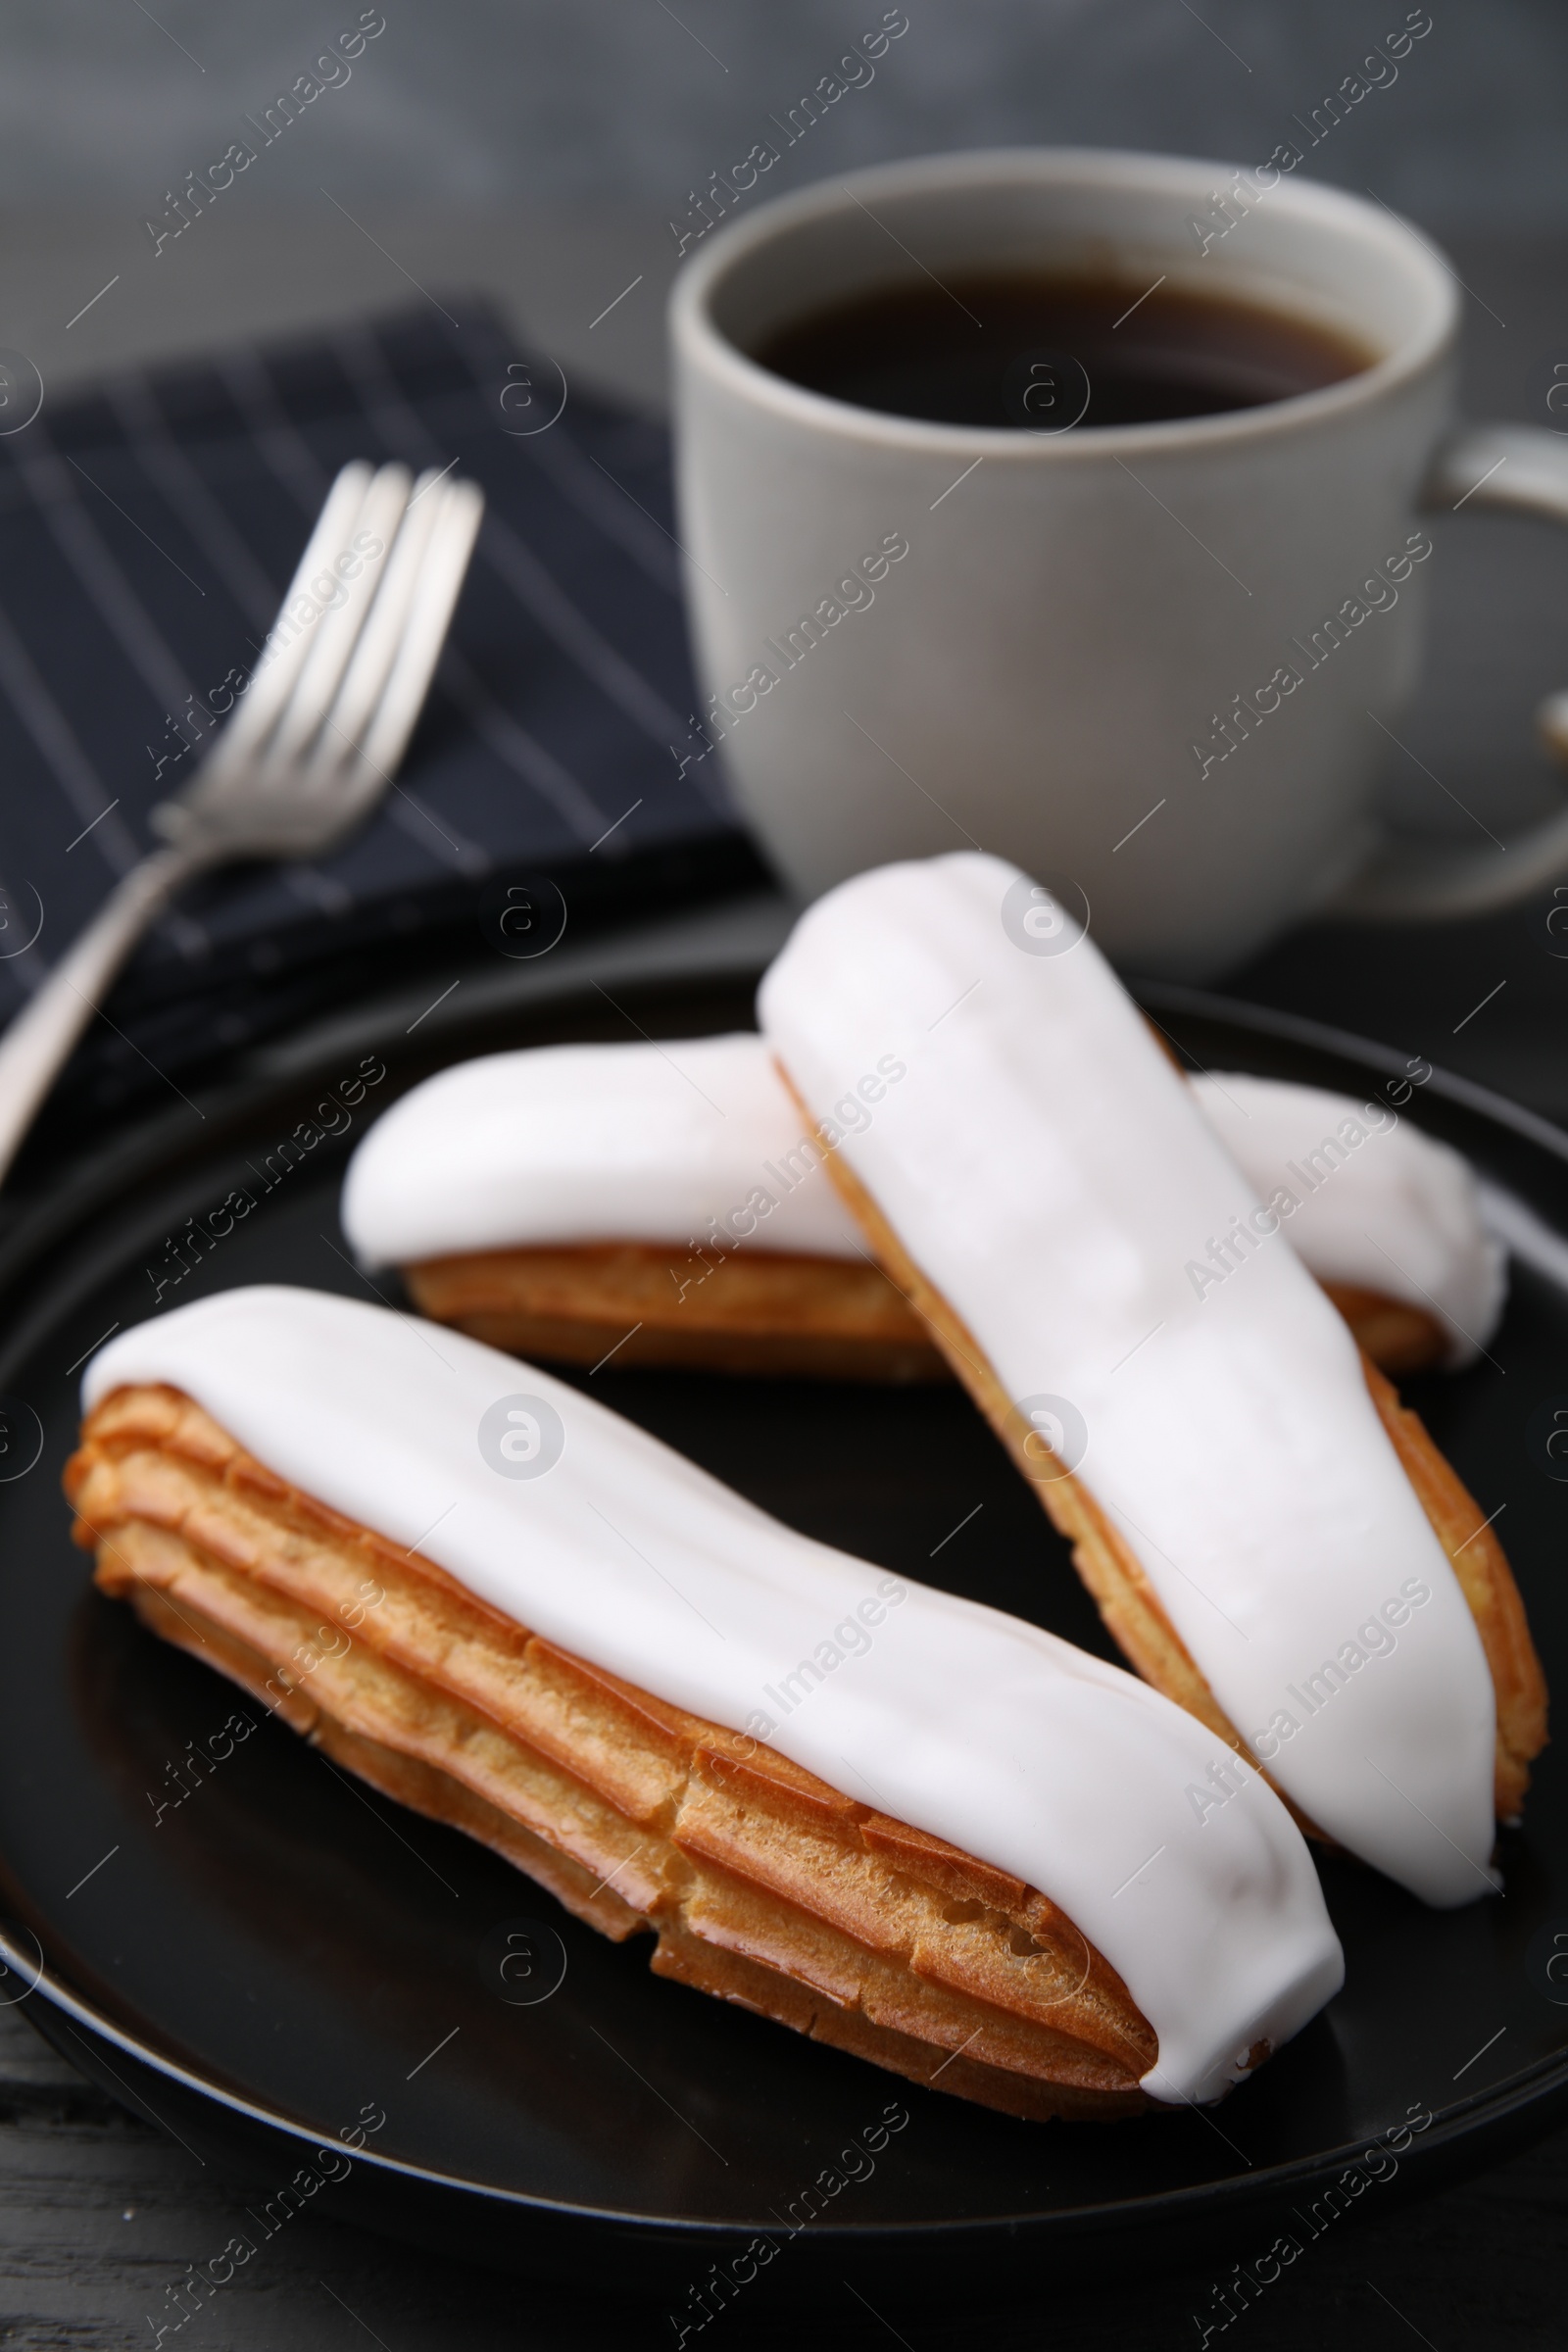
[82,1287,1343,2100]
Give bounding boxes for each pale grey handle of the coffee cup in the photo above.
[1321,425,1568,922]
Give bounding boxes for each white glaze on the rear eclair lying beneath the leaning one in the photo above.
[343,1035,1504,1366]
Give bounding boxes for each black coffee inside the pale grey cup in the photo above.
[753,272,1378,433]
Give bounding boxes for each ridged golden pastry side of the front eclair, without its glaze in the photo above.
[66,1388,1165,2119]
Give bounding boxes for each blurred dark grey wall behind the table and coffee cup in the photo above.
[12,0,1568,228]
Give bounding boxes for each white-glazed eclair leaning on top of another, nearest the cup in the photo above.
[760,854,1544,1905]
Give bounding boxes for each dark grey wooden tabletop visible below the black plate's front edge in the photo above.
[0,2004,1568,2352]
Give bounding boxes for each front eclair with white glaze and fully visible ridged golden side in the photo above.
[66,1289,1343,2119]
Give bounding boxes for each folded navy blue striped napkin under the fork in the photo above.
[0,299,750,1143]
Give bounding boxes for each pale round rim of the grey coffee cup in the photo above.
[667,146,1460,464]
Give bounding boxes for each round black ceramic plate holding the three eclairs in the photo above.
[0,959,1568,2310]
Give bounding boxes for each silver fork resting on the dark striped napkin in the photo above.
[0,464,484,1181]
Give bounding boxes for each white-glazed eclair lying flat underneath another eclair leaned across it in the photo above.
[343,1035,1504,1381]
